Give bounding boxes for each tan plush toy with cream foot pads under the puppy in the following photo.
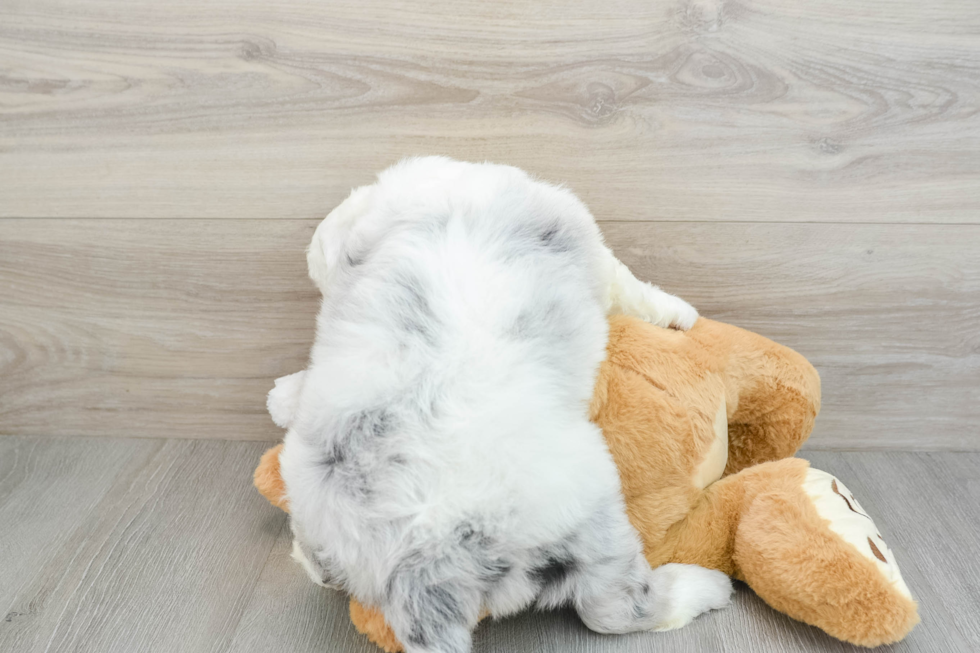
[255,316,919,652]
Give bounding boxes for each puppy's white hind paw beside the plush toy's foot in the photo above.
[654,564,732,630]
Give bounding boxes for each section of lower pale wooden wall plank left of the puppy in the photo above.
[0,220,319,440]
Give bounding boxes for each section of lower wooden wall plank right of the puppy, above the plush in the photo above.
[603,223,980,450]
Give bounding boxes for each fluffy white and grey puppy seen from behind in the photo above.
[270,157,731,653]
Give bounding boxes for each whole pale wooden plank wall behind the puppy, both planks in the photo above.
[0,0,980,449]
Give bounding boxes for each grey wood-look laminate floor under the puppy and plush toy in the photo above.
[0,437,980,653]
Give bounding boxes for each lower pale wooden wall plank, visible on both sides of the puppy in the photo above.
[0,220,980,449]
